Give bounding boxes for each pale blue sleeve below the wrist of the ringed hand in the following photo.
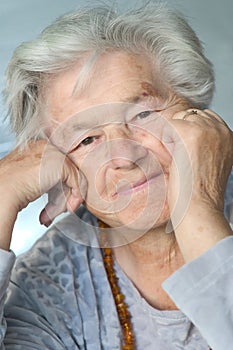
[163,236,233,350]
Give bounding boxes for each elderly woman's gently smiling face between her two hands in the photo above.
[46,52,187,234]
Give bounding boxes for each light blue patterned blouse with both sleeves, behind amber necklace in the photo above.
[0,202,233,350]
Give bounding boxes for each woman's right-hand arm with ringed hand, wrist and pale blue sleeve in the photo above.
[163,110,233,350]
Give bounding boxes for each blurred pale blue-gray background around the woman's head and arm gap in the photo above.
[0,0,233,254]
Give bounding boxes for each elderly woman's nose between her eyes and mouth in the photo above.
[106,124,148,169]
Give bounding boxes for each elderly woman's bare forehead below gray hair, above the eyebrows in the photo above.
[44,52,162,117]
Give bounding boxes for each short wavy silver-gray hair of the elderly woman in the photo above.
[4,1,214,144]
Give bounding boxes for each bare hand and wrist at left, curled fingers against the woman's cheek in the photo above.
[0,140,86,249]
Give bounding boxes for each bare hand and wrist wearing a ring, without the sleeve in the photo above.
[168,109,233,261]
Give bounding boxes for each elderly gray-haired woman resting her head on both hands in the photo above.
[0,3,233,350]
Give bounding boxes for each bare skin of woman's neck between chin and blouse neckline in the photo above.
[113,224,184,310]
